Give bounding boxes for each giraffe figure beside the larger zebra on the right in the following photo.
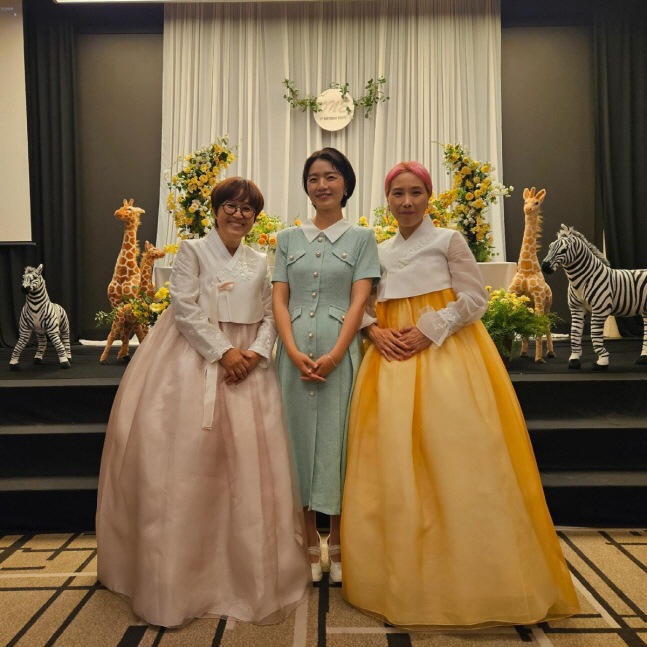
[508,187,555,363]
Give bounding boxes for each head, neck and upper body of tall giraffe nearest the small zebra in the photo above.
[108,199,146,308]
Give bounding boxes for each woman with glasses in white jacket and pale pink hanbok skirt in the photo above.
[97,178,310,627]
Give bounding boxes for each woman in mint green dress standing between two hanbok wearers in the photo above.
[272,148,380,582]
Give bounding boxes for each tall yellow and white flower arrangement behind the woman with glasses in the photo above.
[166,135,236,240]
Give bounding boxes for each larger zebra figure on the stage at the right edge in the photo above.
[541,225,647,371]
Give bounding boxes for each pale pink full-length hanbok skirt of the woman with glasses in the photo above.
[97,309,310,626]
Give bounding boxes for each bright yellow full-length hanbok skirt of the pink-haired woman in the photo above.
[341,289,579,629]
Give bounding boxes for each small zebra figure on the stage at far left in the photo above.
[9,263,72,371]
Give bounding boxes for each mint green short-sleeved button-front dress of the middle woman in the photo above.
[272,225,380,514]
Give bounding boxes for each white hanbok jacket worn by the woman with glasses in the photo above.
[170,229,276,367]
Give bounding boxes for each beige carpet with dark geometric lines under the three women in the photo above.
[0,529,647,647]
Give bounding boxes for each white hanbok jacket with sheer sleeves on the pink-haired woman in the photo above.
[362,217,488,346]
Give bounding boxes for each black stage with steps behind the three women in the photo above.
[0,339,647,532]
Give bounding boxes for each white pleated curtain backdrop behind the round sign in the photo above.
[157,0,505,260]
